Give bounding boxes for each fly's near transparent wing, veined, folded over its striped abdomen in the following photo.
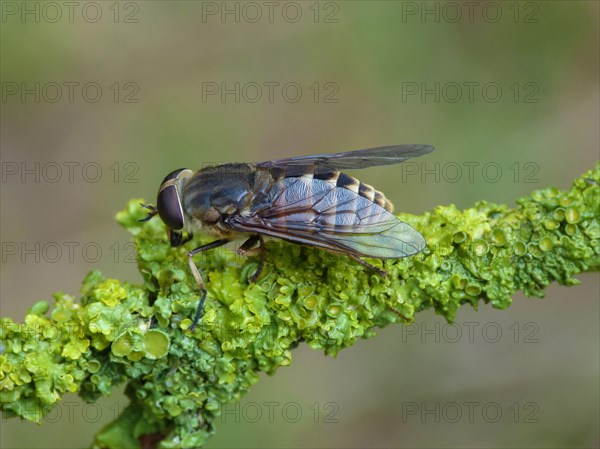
[227,177,425,259]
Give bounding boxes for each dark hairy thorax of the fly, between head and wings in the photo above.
[182,164,255,229]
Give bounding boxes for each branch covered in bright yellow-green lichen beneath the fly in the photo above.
[0,164,600,448]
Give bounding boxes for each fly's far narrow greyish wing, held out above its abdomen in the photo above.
[256,145,433,176]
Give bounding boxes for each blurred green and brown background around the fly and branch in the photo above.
[0,1,600,449]
